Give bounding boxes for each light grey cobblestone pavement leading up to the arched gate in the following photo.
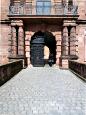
[0,67,86,115]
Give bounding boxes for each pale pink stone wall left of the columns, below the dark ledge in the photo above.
[0,24,10,64]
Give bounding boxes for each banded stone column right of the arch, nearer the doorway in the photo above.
[62,26,68,56]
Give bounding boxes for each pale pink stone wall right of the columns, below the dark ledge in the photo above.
[76,24,86,61]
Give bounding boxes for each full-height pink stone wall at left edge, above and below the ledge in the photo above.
[0,0,10,64]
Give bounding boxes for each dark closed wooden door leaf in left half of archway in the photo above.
[31,37,44,67]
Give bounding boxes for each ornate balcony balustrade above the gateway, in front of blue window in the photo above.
[9,3,78,16]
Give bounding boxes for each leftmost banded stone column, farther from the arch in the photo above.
[11,26,17,57]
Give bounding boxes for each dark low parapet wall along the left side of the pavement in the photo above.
[0,60,23,86]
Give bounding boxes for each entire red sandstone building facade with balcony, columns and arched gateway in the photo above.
[0,0,86,68]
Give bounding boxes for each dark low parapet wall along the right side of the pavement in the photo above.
[69,61,86,81]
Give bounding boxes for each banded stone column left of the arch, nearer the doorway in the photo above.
[18,26,24,57]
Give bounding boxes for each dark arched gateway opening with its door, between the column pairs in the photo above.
[30,31,56,66]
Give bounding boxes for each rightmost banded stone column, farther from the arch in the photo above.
[70,27,76,58]
